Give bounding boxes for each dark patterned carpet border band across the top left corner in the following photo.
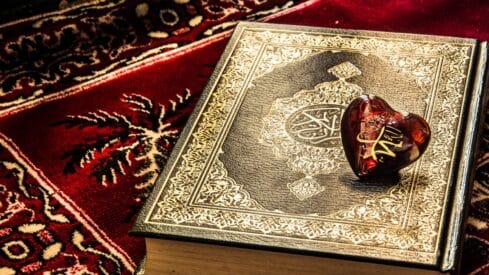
[0,0,294,113]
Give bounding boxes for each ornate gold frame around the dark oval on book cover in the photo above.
[145,27,473,264]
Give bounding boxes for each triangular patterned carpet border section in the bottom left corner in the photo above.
[0,135,135,274]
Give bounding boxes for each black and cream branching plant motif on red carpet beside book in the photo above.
[60,90,191,195]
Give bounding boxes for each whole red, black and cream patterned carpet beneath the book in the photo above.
[0,0,489,274]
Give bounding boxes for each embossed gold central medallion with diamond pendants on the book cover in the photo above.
[260,62,363,200]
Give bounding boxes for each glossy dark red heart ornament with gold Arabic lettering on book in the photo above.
[341,95,430,178]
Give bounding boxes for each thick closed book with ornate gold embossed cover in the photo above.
[133,23,487,274]
